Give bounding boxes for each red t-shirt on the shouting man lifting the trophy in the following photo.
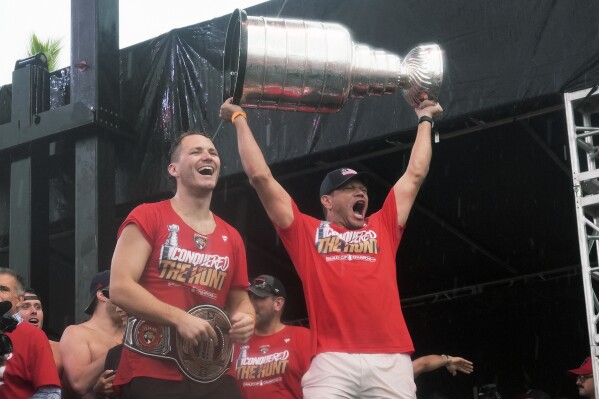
[277,190,414,355]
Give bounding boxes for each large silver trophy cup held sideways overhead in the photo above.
[223,9,443,113]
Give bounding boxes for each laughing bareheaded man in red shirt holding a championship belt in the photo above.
[110,132,255,399]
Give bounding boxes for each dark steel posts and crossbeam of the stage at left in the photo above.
[0,0,126,328]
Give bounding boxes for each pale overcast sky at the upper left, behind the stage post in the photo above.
[0,0,265,86]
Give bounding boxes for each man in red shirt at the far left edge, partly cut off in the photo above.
[0,268,61,399]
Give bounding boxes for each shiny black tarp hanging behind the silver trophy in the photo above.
[108,0,599,206]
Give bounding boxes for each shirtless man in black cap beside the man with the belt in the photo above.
[59,270,124,398]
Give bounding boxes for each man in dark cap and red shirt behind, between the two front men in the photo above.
[231,275,310,399]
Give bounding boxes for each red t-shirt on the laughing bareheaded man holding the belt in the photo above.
[114,200,249,386]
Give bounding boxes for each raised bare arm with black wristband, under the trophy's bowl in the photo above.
[393,101,443,226]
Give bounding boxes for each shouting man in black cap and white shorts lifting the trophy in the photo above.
[220,99,443,399]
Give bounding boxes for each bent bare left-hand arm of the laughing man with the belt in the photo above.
[110,224,217,346]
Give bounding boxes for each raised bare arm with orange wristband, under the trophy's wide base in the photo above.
[220,99,293,228]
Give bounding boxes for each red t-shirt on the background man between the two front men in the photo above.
[229,326,310,399]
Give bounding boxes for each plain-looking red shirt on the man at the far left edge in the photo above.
[0,322,60,399]
